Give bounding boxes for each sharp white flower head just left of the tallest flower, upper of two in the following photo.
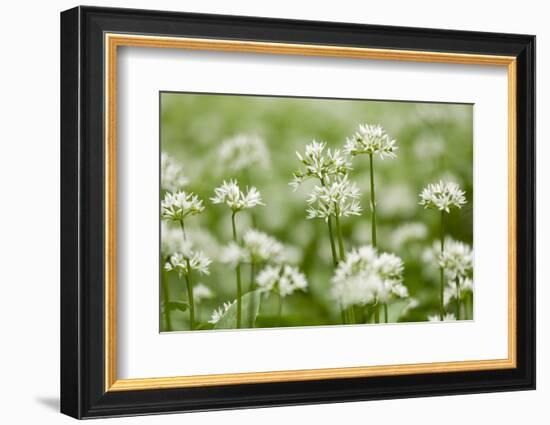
[289,140,351,190]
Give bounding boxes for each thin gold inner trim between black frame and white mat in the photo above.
[104,33,517,391]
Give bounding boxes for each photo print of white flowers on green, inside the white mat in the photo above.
[159,92,475,332]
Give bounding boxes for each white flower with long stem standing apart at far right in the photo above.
[420,181,466,320]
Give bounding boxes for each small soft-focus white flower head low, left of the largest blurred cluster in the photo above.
[256,264,307,297]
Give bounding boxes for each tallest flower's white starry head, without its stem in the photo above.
[344,124,398,159]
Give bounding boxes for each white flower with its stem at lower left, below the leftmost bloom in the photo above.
[164,241,212,330]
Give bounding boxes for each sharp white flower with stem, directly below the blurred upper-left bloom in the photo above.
[211,180,265,329]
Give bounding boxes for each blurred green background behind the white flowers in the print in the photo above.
[161,93,473,330]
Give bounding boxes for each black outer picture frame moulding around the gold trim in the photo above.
[61,7,535,418]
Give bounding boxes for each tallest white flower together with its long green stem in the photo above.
[344,124,398,248]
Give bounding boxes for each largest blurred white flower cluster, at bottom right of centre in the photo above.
[332,245,408,308]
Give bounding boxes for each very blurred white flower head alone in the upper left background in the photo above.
[218,134,269,172]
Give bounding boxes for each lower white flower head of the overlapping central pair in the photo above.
[307,175,361,221]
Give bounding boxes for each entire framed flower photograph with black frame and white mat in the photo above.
[61,7,535,418]
